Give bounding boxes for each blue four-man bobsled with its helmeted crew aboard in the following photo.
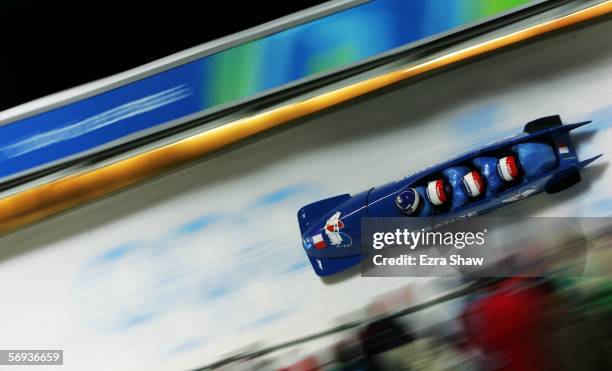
[298,116,601,276]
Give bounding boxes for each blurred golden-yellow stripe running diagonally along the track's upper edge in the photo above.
[0,0,612,233]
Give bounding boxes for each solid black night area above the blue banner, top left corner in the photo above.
[0,0,324,110]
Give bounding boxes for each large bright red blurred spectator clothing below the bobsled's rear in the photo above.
[461,278,550,371]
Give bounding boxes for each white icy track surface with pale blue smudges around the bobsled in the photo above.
[0,20,612,370]
